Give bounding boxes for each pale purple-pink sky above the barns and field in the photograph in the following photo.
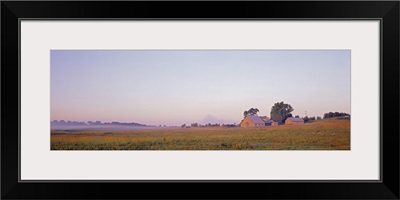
[50,50,351,125]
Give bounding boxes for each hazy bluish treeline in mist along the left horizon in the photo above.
[50,120,147,126]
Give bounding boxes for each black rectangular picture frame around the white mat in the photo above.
[1,1,400,199]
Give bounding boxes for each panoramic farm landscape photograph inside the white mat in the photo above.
[49,50,351,150]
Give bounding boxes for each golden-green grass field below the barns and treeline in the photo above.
[51,120,350,150]
